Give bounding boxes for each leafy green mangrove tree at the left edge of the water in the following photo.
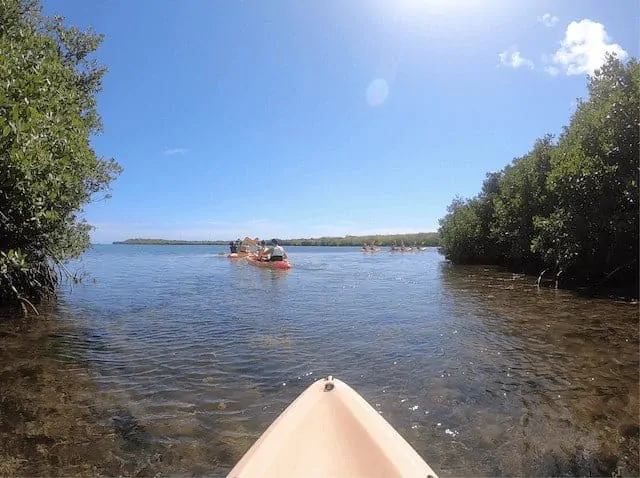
[0,0,120,303]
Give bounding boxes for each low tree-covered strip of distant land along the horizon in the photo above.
[114,232,440,247]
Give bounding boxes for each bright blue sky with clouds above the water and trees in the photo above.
[44,0,639,242]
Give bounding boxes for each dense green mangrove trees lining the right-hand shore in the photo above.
[440,56,640,292]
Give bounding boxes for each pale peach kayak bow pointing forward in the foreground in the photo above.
[228,377,437,478]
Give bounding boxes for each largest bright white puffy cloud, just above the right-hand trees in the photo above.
[546,19,628,75]
